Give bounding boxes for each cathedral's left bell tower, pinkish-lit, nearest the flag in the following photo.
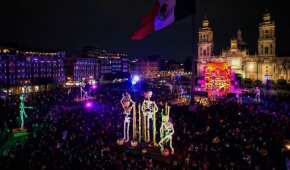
[197,17,213,76]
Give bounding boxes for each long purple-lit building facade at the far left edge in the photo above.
[0,48,65,86]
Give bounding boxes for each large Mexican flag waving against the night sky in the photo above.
[131,0,195,40]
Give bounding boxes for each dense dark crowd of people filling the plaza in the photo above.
[0,84,290,170]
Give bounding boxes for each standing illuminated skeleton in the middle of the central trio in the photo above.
[142,91,158,142]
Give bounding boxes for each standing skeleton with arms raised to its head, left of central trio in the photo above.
[121,93,135,142]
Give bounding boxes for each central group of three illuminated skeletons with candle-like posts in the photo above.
[117,91,174,156]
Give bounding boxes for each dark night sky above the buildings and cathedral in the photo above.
[0,0,290,59]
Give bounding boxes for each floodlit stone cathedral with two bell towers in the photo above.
[197,12,290,82]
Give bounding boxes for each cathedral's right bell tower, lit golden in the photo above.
[258,12,276,57]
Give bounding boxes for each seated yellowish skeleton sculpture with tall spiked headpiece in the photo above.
[159,105,174,155]
